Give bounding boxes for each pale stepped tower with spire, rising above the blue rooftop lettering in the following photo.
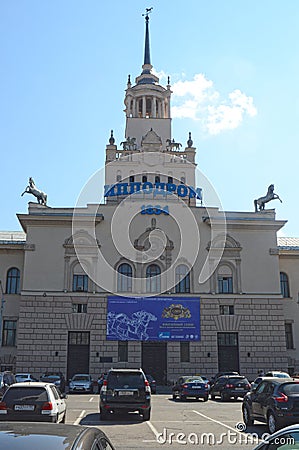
[105,10,196,206]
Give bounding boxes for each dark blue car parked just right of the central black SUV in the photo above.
[172,376,209,402]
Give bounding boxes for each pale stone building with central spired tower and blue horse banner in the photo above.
[0,16,299,383]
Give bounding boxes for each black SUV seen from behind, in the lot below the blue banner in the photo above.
[100,369,151,420]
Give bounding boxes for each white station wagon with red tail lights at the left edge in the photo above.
[0,381,66,423]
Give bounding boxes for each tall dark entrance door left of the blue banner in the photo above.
[67,331,89,379]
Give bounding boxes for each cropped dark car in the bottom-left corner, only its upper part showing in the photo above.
[0,422,115,450]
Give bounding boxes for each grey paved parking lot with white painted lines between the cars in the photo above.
[66,394,267,450]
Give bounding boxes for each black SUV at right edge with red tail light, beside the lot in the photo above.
[242,378,299,434]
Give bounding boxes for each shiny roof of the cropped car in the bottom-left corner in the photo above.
[0,422,110,450]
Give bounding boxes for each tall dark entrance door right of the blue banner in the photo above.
[217,333,239,372]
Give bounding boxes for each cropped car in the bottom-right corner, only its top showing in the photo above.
[253,425,299,450]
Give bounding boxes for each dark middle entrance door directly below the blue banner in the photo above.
[142,342,167,385]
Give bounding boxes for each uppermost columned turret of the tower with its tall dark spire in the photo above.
[125,10,171,147]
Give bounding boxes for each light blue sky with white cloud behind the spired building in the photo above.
[0,0,299,237]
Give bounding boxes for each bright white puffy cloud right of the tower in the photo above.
[171,73,257,134]
